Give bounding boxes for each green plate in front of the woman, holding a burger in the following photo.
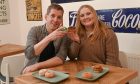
[75,67,109,81]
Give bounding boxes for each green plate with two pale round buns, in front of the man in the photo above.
[32,70,69,83]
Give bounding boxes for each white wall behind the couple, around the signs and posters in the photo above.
[0,0,140,54]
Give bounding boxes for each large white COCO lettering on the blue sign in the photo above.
[112,9,140,28]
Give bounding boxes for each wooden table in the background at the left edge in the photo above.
[0,44,25,58]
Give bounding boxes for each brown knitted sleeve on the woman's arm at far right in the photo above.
[105,29,121,66]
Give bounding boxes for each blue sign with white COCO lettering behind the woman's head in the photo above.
[69,8,140,33]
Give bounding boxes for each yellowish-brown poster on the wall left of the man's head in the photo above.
[26,0,42,21]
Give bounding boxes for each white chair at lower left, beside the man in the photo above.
[0,54,25,84]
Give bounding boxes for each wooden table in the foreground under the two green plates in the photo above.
[15,61,138,84]
